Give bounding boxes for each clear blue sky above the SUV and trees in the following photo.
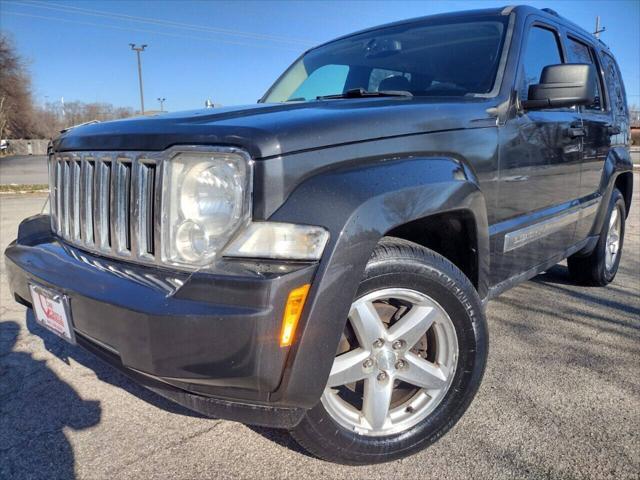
[0,0,640,111]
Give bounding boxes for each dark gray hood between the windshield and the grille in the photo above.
[54,97,495,159]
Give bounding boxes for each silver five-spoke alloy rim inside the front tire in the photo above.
[322,288,458,435]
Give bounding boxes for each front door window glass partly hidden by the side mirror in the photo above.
[519,27,562,100]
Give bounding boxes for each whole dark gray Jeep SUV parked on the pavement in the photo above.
[6,7,632,464]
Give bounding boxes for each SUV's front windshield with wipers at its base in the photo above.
[263,17,507,102]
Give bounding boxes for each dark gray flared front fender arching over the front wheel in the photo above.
[270,157,489,407]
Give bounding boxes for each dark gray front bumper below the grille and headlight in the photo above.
[5,215,317,427]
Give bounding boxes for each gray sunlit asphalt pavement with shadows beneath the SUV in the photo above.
[0,175,640,480]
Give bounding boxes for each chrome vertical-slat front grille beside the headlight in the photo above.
[49,152,161,263]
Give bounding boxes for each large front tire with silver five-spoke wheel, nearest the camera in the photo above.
[291,238,488,465]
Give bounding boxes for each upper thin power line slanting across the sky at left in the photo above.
[8,0,315,46]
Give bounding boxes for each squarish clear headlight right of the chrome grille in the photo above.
[161,151,251,268]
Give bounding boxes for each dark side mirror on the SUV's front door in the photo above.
[522,63,596,110]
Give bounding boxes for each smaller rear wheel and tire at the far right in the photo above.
[567,188,627,287]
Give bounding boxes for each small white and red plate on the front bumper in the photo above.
[29,284,76,344]
